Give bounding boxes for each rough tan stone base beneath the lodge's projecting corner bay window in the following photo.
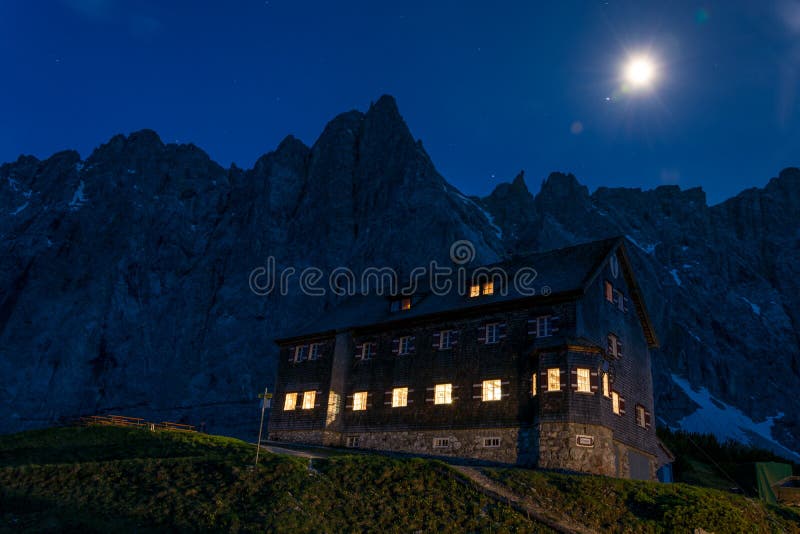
[538,422,617,477]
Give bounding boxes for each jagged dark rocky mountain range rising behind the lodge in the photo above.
[0,97,800,460]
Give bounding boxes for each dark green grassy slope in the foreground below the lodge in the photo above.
[0,427,800,533]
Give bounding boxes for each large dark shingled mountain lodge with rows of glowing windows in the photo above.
[269,239,664,479]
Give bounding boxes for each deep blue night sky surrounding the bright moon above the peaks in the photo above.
[0,0,800,203]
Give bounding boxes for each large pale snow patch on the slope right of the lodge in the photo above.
[672,374,800,461]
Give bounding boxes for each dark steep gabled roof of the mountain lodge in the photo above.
[276,237,657,346]
